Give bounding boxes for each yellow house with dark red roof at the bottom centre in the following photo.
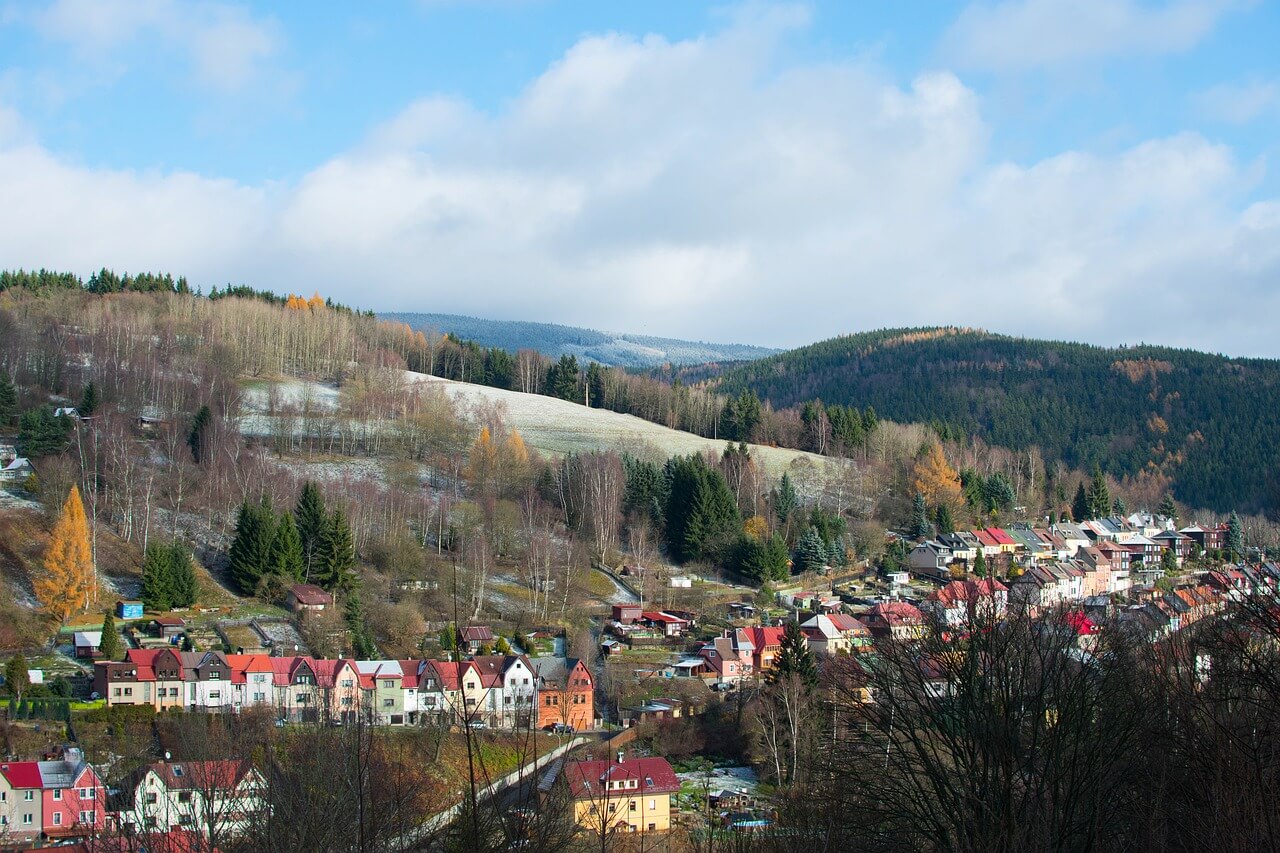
[564,753,680,834]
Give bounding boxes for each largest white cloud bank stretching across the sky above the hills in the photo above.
[0,12,1280,355]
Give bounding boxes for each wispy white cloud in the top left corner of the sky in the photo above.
[29,0,280,92]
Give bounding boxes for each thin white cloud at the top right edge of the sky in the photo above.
[942,0,1239,70]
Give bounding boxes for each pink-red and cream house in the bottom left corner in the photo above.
[0,747,106,840]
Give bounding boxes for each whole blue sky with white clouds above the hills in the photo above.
[0,0,1280,357]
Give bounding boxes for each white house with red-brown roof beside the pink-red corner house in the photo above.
[116,760,266,839]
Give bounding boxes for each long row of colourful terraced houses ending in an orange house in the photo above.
[93,648,595,729]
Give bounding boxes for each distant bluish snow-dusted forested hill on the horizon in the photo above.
[380,313,777,368]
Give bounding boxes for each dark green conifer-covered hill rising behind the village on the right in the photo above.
[716,328,1280,512]
